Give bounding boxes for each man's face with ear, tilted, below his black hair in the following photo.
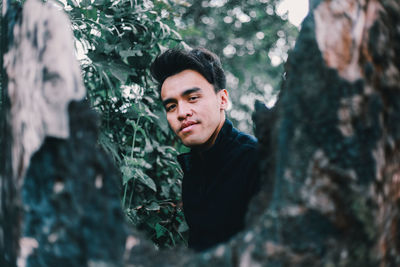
[161,70,228,148]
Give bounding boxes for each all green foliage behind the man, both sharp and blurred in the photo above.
[54,0,298,248]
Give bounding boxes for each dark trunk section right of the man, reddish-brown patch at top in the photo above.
[250,0,400,266]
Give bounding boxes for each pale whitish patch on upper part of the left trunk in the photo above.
[4,0,85,183]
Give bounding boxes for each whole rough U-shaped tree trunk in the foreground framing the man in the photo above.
[0,0,400,266]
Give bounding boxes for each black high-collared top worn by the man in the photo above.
[178,120,259,251]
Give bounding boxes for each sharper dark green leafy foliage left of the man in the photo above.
[65,0,191,247]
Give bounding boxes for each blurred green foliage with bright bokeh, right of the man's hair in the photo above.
[176,0,298,133]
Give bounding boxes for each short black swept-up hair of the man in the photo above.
[150,48,226,92]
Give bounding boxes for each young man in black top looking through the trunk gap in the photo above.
[151,48,259,251]
